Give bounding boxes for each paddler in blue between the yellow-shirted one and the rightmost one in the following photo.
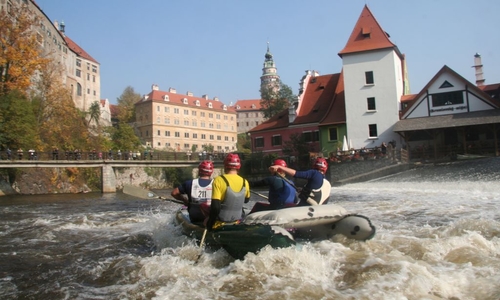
[250,159,299,213]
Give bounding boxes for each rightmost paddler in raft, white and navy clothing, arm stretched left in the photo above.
[269,157,332,206]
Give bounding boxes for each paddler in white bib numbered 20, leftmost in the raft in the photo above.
[170,160,214,223]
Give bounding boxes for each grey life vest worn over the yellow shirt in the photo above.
[219,175,247,223]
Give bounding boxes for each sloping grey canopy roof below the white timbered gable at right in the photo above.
[393,109,500,132]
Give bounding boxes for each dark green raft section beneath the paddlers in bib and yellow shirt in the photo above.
[176,211,295,259]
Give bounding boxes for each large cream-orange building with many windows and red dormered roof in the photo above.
[135,84,237,155]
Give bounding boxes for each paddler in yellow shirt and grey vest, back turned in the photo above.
[206,153,250,231]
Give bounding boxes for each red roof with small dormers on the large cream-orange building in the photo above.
[139,90,236,113]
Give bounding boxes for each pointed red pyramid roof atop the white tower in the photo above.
[339,5,401,57]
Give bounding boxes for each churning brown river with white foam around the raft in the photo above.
[0,158,500,300]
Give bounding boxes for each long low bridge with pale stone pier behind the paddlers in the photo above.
[0,160,223,193]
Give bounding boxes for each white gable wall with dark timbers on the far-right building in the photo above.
[401,65,500,119]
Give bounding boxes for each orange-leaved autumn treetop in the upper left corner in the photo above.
[0,5,49,94]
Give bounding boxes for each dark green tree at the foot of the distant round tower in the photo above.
[260,81,297,119]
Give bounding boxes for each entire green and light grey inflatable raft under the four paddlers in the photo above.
[176,204,376,259]
